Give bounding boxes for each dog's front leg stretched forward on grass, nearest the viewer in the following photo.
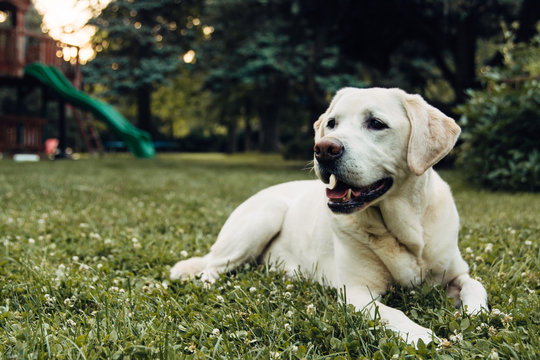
[346,286,437,345]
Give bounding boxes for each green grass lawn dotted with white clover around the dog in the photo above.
[0,154,540,359]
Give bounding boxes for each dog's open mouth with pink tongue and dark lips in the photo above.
[326,174,394,214]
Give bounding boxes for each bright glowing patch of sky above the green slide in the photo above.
[33,0,111,61]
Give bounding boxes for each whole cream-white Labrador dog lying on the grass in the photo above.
[171,88,487,343]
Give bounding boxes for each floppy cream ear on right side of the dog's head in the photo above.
[403,94,461,175]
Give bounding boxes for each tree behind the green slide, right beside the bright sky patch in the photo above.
[84,0,202,136]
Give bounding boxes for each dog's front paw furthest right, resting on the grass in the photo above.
[446,273,488,315]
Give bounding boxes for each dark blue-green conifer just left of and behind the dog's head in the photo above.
[198,0,360,151]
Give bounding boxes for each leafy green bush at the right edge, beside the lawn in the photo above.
[458,26,540,191]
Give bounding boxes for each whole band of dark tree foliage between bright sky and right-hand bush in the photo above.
[87,0,540,164]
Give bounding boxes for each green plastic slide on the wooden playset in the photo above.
[24,63,156,158]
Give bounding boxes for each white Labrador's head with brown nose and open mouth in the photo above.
[314,88,460,213]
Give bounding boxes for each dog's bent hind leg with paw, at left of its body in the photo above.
[170,187,289,282]
